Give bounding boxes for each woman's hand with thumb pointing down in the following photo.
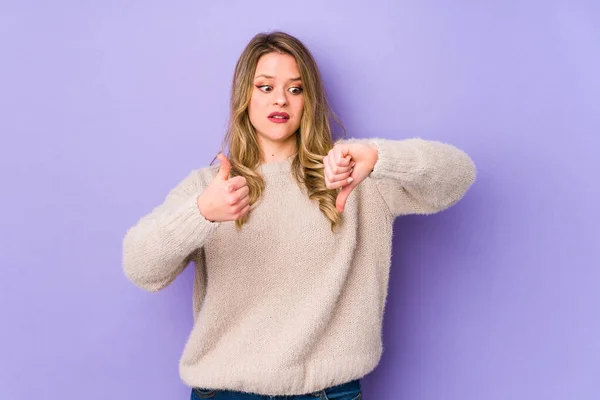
[323,143,377,212]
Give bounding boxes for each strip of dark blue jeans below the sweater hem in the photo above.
[190,379,363,400]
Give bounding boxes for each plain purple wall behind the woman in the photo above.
[0,0,600,400]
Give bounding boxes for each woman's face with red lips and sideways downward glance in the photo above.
[248,53,304,152]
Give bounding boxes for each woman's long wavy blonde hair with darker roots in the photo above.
[211,31,345,231]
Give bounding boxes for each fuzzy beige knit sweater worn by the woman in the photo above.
[123,139,475,395]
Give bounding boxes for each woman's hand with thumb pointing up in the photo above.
[196,154,250,222]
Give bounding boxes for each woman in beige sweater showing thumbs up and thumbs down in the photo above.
[123,32,475,400]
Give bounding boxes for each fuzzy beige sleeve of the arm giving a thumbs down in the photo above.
[367,138,476,216]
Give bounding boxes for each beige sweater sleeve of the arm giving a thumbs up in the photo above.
[122,170,219,292]
